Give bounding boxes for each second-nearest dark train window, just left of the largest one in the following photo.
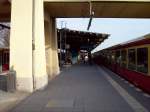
[128,49,136,70]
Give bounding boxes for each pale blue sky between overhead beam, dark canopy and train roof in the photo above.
[57,18,150,52]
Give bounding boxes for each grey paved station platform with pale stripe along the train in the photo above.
[11,64,150,112]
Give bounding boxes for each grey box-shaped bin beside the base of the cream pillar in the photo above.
[0,71,16,92]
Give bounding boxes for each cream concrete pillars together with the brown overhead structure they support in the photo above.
[0,0,150,92]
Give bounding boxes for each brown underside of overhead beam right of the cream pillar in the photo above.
[44,0,150,18]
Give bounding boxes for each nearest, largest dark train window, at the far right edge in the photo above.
[137,48,148,73]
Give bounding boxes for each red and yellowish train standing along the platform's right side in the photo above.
[93,34,150,93]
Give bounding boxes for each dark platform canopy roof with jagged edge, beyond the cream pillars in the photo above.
[57,28,110,50]
